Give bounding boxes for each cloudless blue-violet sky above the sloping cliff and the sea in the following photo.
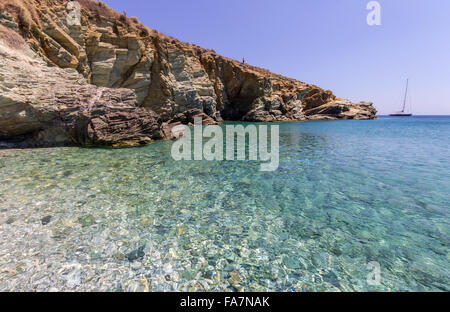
[104,0,450,115]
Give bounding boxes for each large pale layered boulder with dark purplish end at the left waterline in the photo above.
[0,30,162,146]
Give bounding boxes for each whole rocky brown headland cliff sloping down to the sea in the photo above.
[0,0,376,145]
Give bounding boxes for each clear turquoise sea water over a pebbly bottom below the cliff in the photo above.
[0,117,450,291]
